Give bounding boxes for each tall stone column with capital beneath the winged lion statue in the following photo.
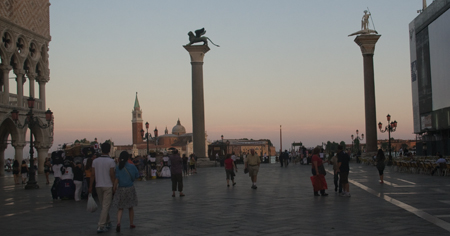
[184,45,209,158]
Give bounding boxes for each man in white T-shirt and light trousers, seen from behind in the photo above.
[89,143,116,233]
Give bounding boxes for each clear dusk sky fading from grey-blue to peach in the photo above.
[8,0,430,158]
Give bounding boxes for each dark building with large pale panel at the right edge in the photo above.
[409,0,450,156]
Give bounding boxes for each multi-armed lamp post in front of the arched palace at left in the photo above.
[11,97,53,189]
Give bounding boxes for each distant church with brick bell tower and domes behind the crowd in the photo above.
[114,93,209,157]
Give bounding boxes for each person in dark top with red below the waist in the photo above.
[311,147,328,196]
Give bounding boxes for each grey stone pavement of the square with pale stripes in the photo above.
[0,163,450,236]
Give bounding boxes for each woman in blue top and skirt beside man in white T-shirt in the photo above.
[113,151,139,232]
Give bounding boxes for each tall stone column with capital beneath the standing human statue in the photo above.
[355,34,381,153]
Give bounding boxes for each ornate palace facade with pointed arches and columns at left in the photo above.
[0,0,53,175]
